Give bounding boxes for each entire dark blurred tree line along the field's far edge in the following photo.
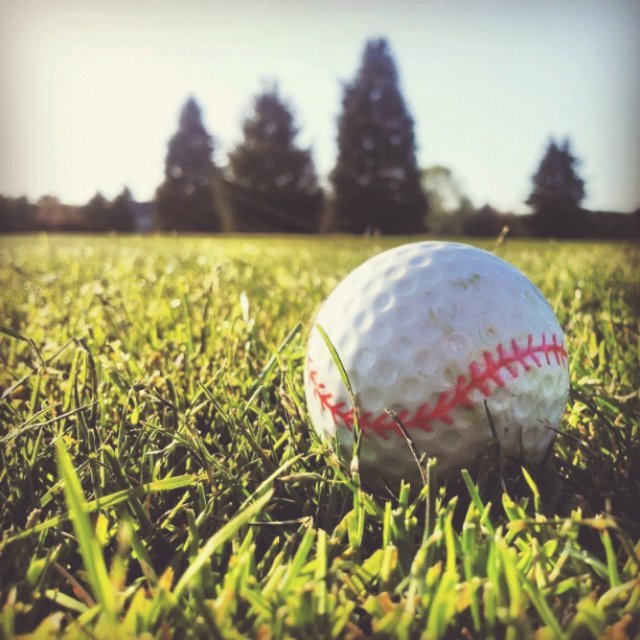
[0,38,640,237]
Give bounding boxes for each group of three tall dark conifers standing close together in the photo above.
[156,39,427,233]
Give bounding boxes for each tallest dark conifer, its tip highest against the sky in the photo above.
[331,39,427,233]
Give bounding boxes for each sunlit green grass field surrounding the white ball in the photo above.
[0,236,640,639]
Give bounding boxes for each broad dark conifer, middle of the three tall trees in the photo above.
[227,86,323,233]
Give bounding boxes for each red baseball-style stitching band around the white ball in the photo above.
[308,333,567,438]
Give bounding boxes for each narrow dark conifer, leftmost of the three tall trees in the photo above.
[156,98,221,231]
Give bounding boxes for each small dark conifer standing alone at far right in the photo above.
[527,139,586,237]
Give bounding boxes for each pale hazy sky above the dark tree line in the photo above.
[0,0,640,212]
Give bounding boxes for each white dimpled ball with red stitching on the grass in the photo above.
[305,242,569,484]
